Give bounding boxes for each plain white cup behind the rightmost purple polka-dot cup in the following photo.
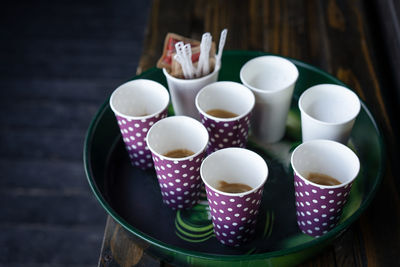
[299,84,361,144]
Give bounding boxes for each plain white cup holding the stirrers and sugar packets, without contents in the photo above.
[163,64,220,120]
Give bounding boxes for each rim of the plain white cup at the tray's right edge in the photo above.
[298,83,361,126]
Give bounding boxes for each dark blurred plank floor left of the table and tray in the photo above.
[0,0,151,266]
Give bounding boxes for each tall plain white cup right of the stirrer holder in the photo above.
[240,56,299,143]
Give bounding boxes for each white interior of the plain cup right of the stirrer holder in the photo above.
[240,56,299,93]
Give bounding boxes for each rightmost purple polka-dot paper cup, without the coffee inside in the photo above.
[291,140,360,237]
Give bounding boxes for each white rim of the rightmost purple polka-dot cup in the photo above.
[290,139,360,189]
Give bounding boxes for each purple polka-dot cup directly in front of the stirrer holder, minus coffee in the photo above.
[195,81,255,154]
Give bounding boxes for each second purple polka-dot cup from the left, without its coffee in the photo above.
[147,116,208,210]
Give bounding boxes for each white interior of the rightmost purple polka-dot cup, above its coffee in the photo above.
[291,140,360,188]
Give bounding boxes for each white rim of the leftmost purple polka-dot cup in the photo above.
[109,79,169,120]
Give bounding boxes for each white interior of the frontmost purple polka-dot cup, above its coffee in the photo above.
[200,147,268,195]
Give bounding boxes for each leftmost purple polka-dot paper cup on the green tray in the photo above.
[110,79,169,169]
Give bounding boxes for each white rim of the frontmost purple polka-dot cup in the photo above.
[200,147,269,197]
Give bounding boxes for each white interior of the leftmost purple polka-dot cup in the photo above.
[110,79,169,117]
